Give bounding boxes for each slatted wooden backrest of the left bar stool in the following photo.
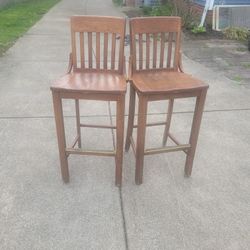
[71,16,126,74]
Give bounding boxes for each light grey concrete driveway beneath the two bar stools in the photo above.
[0,0,250,250]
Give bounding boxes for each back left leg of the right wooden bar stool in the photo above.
[125,84,135,152]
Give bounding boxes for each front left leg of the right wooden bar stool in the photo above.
[135,95,148,185]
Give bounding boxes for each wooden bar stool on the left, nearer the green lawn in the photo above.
[51,16,126,186]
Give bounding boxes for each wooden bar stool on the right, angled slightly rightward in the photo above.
[125,17,208,184]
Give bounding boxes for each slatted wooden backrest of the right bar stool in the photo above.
[130,16,181,73]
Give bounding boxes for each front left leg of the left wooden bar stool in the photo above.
[52,92,69,183]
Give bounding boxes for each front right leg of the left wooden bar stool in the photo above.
[115,95,125,187]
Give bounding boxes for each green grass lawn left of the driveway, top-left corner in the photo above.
[0,0,60,55]
